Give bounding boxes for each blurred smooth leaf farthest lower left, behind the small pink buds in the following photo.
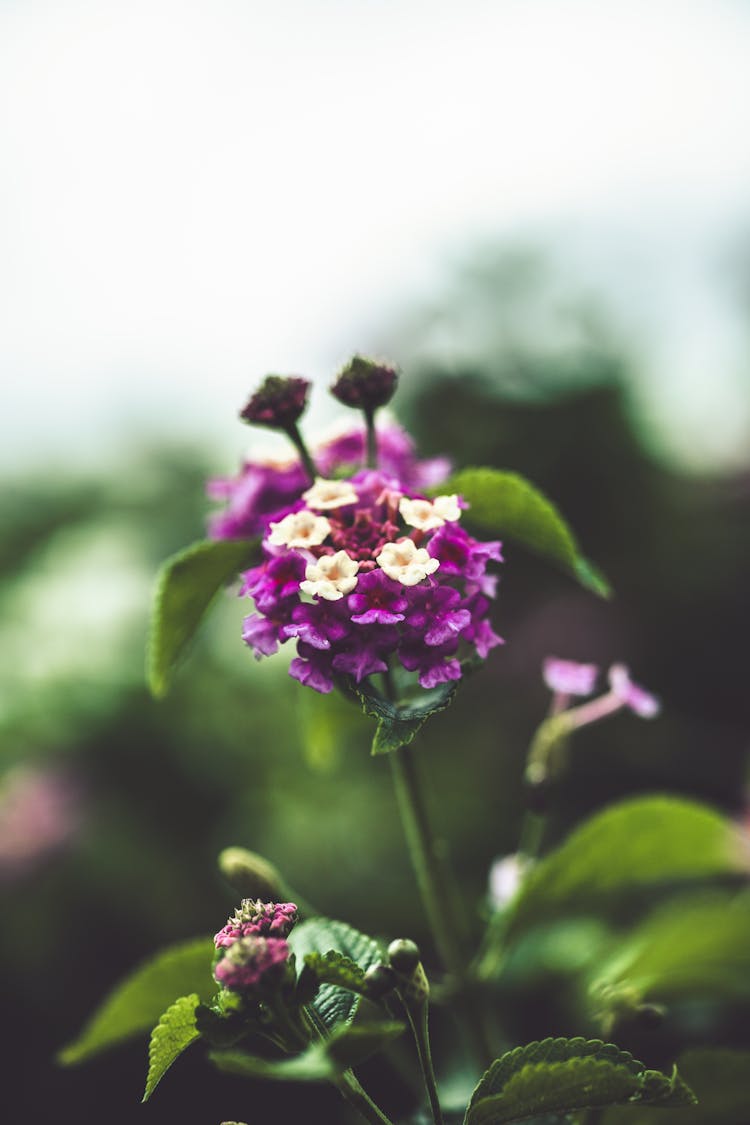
[57,937,216,1065]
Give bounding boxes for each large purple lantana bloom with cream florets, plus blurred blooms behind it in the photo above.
[206,364,501,693]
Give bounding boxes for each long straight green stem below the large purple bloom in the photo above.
[388,746,494,1067]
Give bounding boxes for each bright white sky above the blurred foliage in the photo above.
[0,0,750,469]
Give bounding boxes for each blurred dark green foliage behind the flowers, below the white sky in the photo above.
[0,261,750,1125]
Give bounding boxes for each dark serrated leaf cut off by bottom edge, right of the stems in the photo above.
[466,1038,695,1125]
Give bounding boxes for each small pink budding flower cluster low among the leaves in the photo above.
[214,899,297,992]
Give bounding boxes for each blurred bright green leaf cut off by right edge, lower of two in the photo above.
[590,892,750,1022]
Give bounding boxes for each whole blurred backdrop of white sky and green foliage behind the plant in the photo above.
[0,0,750,1125]
